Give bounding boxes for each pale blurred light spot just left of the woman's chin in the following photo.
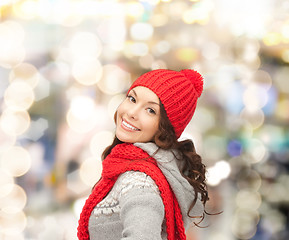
[89,131,114,159]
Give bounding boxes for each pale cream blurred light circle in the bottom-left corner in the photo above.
[0,211,27,234]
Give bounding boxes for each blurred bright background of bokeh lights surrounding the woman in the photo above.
[0,0,289,240]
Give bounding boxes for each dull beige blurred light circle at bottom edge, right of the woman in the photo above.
[231,209,260,239]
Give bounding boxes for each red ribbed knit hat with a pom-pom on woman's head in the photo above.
[128,69,203,137]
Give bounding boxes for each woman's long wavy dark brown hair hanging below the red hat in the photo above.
[102,102,209,225]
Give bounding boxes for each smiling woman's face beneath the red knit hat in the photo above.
[116,86,160,143]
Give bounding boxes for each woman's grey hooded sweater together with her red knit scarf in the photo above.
[78,143,204,240]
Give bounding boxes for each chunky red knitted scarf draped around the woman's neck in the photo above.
[77,143,186,240]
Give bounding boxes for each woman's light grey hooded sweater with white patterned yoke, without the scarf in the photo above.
[88,143,204,240]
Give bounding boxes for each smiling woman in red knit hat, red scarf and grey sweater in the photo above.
[78,69,208,240]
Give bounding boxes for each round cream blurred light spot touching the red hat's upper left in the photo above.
[97,65,131,95]
